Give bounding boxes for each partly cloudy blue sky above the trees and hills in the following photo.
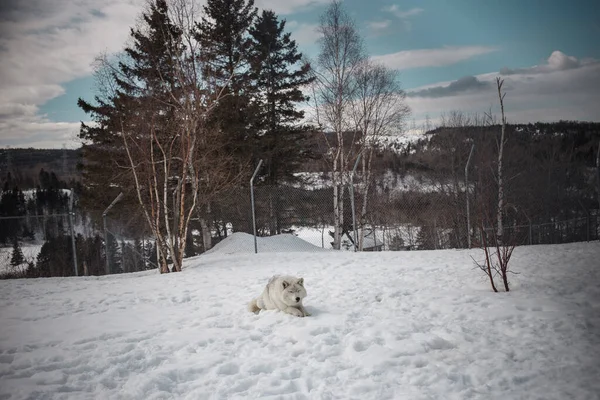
[0,0,600,148]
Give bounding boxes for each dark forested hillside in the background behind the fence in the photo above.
[0,117,600,277]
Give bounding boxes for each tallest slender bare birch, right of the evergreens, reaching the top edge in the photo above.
[314,0,366,249]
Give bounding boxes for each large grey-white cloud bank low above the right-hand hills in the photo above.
[407,52,600,123]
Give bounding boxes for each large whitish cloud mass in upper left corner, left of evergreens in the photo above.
[0,0,144,147]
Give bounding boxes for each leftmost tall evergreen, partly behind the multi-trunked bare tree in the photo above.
[78,0,182,219]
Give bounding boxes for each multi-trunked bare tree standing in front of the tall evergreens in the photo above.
[90,0,238,272]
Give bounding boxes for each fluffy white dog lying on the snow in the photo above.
[248,275,310,317]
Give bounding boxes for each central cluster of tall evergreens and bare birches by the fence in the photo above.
[78,0,409,272]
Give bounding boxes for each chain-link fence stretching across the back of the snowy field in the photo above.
[0,179,600,277]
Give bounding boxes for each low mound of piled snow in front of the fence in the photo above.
[205,232,327,254]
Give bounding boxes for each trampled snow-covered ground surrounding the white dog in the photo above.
[0,235,600,400]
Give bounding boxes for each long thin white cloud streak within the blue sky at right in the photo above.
[373,46,498,70]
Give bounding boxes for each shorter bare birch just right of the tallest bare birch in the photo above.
[350,60,410,251]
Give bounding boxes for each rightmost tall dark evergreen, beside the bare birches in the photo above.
[250,11,314,184]
